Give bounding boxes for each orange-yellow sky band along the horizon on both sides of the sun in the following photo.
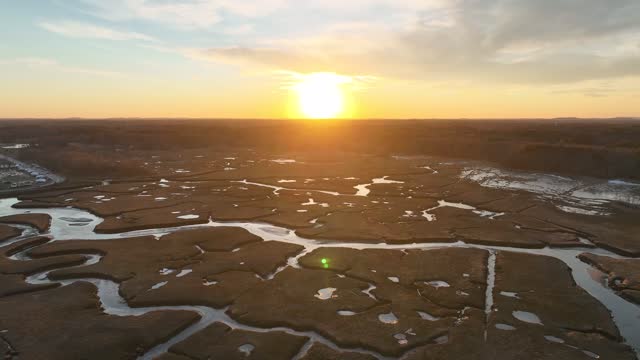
[0,71,640,119]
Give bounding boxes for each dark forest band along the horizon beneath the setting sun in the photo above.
[0,119,640,179]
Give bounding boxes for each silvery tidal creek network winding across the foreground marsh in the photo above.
[0,198,640,359]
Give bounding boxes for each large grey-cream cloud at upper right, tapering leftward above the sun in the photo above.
[191,0,640,84]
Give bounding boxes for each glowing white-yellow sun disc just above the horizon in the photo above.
[293,73,351,119]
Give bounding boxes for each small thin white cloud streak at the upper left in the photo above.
[38,20,157,42]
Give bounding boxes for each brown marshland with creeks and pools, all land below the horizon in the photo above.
[0,119,640,360]
